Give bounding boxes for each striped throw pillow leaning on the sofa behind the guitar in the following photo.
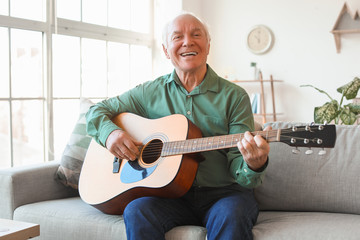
[56,98,94,189]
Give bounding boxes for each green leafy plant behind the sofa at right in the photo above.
[300,77,360,125]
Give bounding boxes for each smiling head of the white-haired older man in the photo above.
[163,14,210,74]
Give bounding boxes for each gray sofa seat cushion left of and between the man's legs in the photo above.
[14,197,206,240]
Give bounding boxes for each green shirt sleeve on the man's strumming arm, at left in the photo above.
[86,85,144,147]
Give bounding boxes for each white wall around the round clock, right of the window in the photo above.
[177,0,360,122]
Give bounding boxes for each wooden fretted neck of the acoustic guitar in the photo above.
[161,129,281,157]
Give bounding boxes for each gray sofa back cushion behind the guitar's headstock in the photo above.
[255,123,360,214]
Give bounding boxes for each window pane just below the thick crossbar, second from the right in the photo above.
[108,42,130,97]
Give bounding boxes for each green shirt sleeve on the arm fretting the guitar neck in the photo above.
[228,89,267,188]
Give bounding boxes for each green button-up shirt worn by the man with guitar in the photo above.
[86,66,264,188]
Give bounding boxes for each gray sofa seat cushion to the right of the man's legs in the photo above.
[253,211,360,240]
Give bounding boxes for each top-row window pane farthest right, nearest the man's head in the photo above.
[131,0,150,33]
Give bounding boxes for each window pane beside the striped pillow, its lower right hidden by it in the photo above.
[54,100,80,159]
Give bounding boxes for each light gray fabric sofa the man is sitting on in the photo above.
[0,123,360,240]
